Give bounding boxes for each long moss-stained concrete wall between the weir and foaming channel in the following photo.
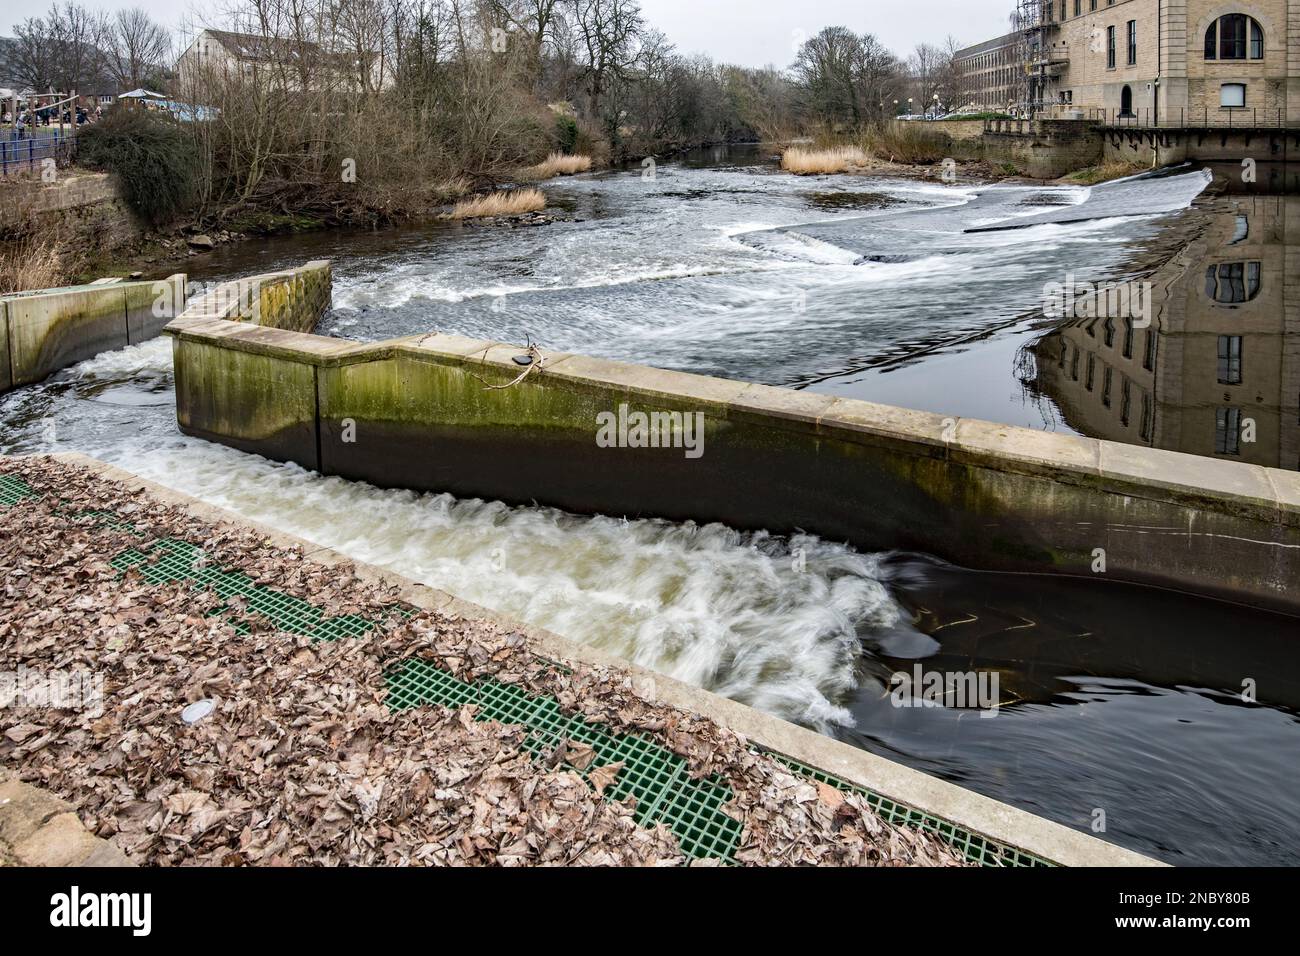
[159,319,1300,611]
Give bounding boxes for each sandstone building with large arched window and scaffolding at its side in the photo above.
[956,0,1300,126]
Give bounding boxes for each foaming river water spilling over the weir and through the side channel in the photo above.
[0,150,1300,862]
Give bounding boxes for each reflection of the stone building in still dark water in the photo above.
[1032,180,1300,470]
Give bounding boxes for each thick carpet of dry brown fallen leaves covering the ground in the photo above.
[0,458,963,866]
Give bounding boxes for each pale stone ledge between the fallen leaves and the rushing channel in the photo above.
[35,453,1164,866]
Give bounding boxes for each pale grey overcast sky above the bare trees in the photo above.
[0,0,1014,66]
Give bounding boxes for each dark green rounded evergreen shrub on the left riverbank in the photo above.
[78,107,198,225]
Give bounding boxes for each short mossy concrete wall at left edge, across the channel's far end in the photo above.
[0,273,185,390]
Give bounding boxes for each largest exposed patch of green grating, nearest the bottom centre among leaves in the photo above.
[386,659,741,862]
